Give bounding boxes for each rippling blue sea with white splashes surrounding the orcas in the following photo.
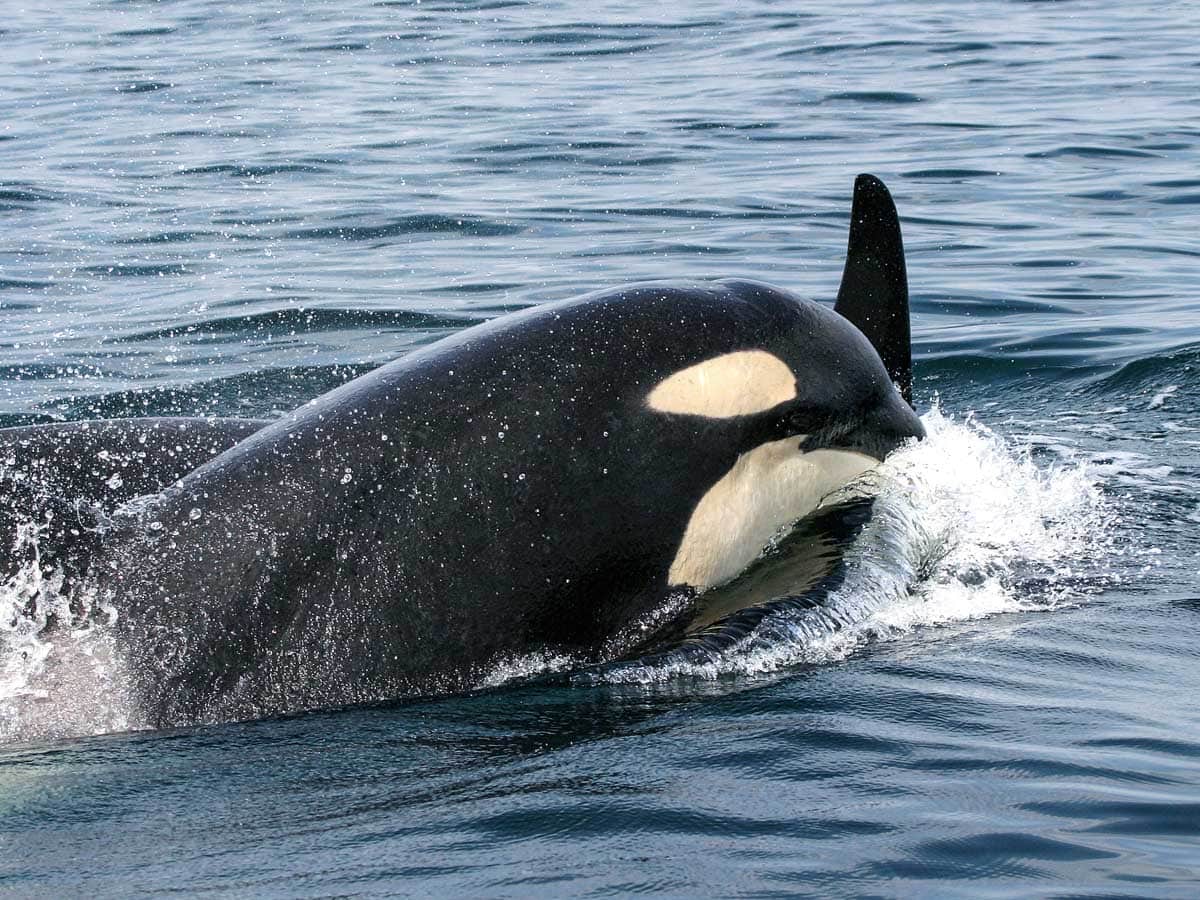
[0,0,1200,898]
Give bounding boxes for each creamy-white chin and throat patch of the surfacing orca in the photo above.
[667,437,878,590]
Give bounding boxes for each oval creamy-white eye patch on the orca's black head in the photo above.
[646,350,796,419]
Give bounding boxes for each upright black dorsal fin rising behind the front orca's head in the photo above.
[834,175,912,406]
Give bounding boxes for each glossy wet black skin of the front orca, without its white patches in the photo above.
[96,281,922,725]
